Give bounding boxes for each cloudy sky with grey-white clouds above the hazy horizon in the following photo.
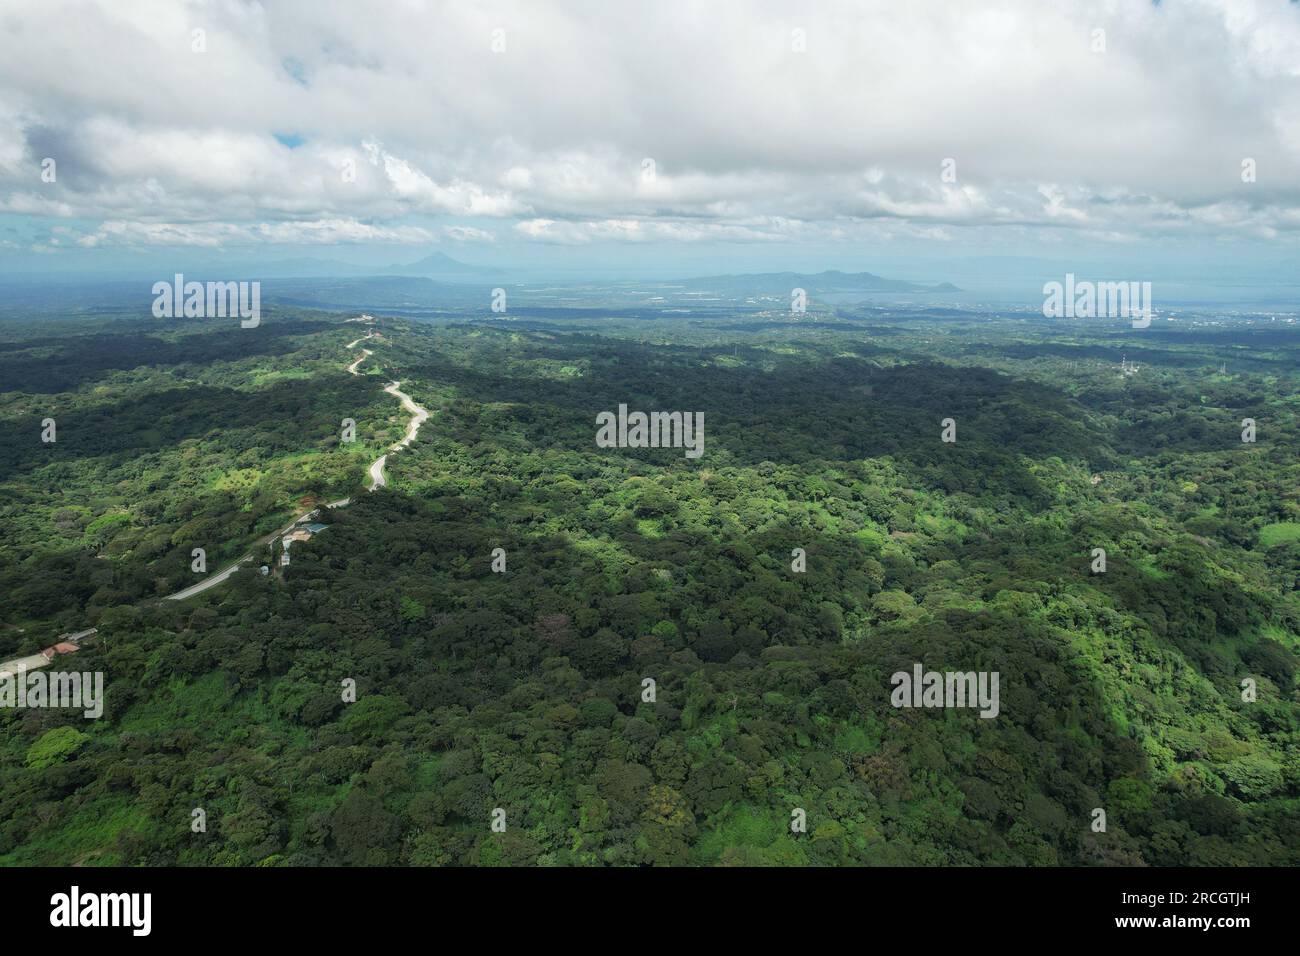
[0,0,1300,295]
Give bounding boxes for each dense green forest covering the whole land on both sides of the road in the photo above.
[0,307,1300,866]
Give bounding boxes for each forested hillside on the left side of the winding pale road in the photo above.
[0,319,402,642]
